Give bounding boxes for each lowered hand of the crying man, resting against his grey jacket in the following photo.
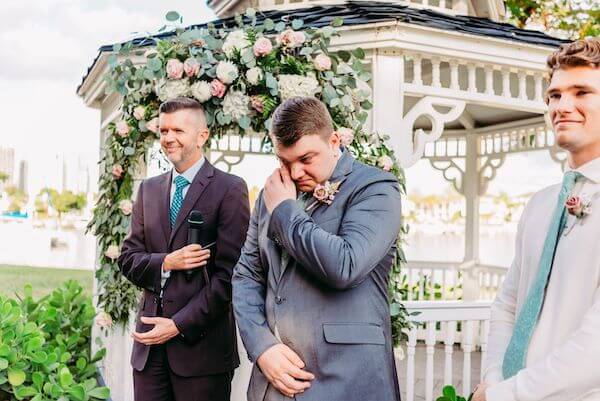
[256,344,315,398]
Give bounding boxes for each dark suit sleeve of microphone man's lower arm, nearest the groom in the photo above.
[172,179,250,343]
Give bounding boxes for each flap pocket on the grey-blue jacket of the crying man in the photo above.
[323,323,385,345]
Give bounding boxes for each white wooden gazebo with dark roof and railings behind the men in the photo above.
[78,0,565,401]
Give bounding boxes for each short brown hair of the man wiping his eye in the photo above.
[271,97,333,147]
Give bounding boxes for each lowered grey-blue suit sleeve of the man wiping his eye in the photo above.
[233,193,279,362]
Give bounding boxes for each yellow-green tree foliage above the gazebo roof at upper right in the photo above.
[505,0,600,40]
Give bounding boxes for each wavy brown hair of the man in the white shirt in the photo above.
[547,38,600,79]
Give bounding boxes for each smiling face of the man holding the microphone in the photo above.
[158,109,208,172]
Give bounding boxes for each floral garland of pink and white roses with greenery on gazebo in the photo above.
[89,9,405,335]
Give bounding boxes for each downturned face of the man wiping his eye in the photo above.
[274,132,340,192]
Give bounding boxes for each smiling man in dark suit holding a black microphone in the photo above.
[118,98,250,401]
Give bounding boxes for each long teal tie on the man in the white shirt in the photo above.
[502,171,582,379]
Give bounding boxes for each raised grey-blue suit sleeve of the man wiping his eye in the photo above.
[268,177,401,290]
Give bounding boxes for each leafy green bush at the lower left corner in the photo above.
[0,281,109,401]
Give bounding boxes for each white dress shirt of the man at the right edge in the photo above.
[484,158,600,401]
